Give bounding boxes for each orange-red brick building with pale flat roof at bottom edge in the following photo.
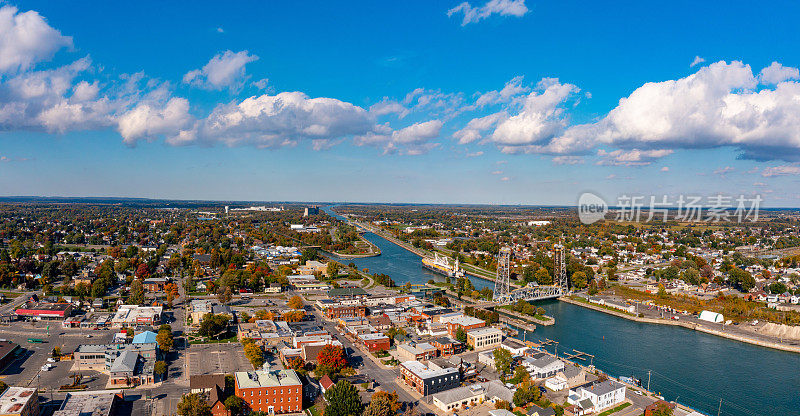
[234,369,303,414]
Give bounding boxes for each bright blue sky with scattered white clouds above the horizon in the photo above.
[0,0,800,206]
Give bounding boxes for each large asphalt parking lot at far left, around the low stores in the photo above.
[0,322,113,389]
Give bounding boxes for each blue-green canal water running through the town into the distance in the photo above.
[325,207,800,416]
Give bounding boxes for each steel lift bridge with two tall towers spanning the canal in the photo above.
[492,244,569,304]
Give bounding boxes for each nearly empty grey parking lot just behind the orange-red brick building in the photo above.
[187,342,253,376]
